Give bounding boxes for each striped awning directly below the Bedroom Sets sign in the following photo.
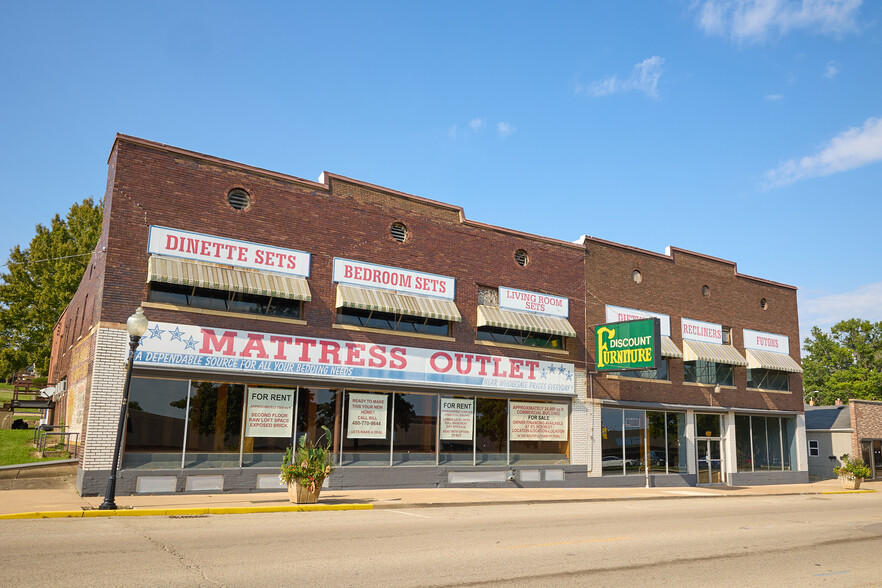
[337,284,462,322]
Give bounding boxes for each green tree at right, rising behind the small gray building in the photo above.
[802,319,882,404]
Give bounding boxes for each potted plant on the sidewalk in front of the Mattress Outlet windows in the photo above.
[279,426,334,504]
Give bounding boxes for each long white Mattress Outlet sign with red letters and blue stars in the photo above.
[129,323,575,395]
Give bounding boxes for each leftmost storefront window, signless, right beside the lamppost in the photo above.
[123,377,190,469]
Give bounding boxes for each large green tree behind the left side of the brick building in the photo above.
[0,198,104,378]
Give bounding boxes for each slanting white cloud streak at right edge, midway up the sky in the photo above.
[764,118,882,189]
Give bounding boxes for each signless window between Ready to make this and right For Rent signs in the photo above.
[392,394,438,466]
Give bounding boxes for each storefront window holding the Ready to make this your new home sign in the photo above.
[341,390,392,466]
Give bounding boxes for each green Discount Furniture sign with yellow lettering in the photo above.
[595,318,661,371]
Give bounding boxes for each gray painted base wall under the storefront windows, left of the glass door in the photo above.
[77,465,708,496]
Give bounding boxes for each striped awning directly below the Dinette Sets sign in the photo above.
[147,255,312,302]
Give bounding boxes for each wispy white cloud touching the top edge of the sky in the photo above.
[693,0,862,42]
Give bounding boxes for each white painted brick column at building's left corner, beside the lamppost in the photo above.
[82,328,129,470]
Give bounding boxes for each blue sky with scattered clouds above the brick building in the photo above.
[0,0,882,344]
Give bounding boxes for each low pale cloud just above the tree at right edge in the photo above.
[799,282,882,341]
